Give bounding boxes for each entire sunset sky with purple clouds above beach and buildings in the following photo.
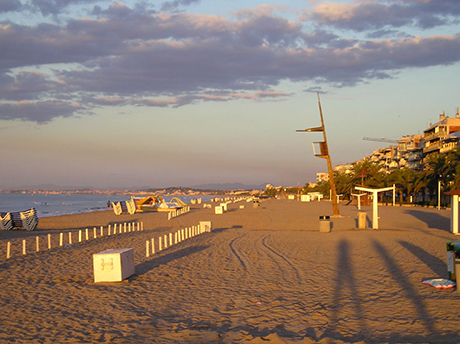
[0,0,460,189]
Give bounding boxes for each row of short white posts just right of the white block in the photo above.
[145,221,212,257]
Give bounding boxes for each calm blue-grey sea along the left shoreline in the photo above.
[0,193,211,217]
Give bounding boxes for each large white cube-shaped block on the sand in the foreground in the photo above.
[93,248,134,283]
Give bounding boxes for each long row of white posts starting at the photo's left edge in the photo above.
[6,222,144,258]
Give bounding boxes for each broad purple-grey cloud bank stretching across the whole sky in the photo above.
[0,0,460,123]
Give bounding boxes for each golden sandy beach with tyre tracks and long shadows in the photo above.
[0,200,460,343]
